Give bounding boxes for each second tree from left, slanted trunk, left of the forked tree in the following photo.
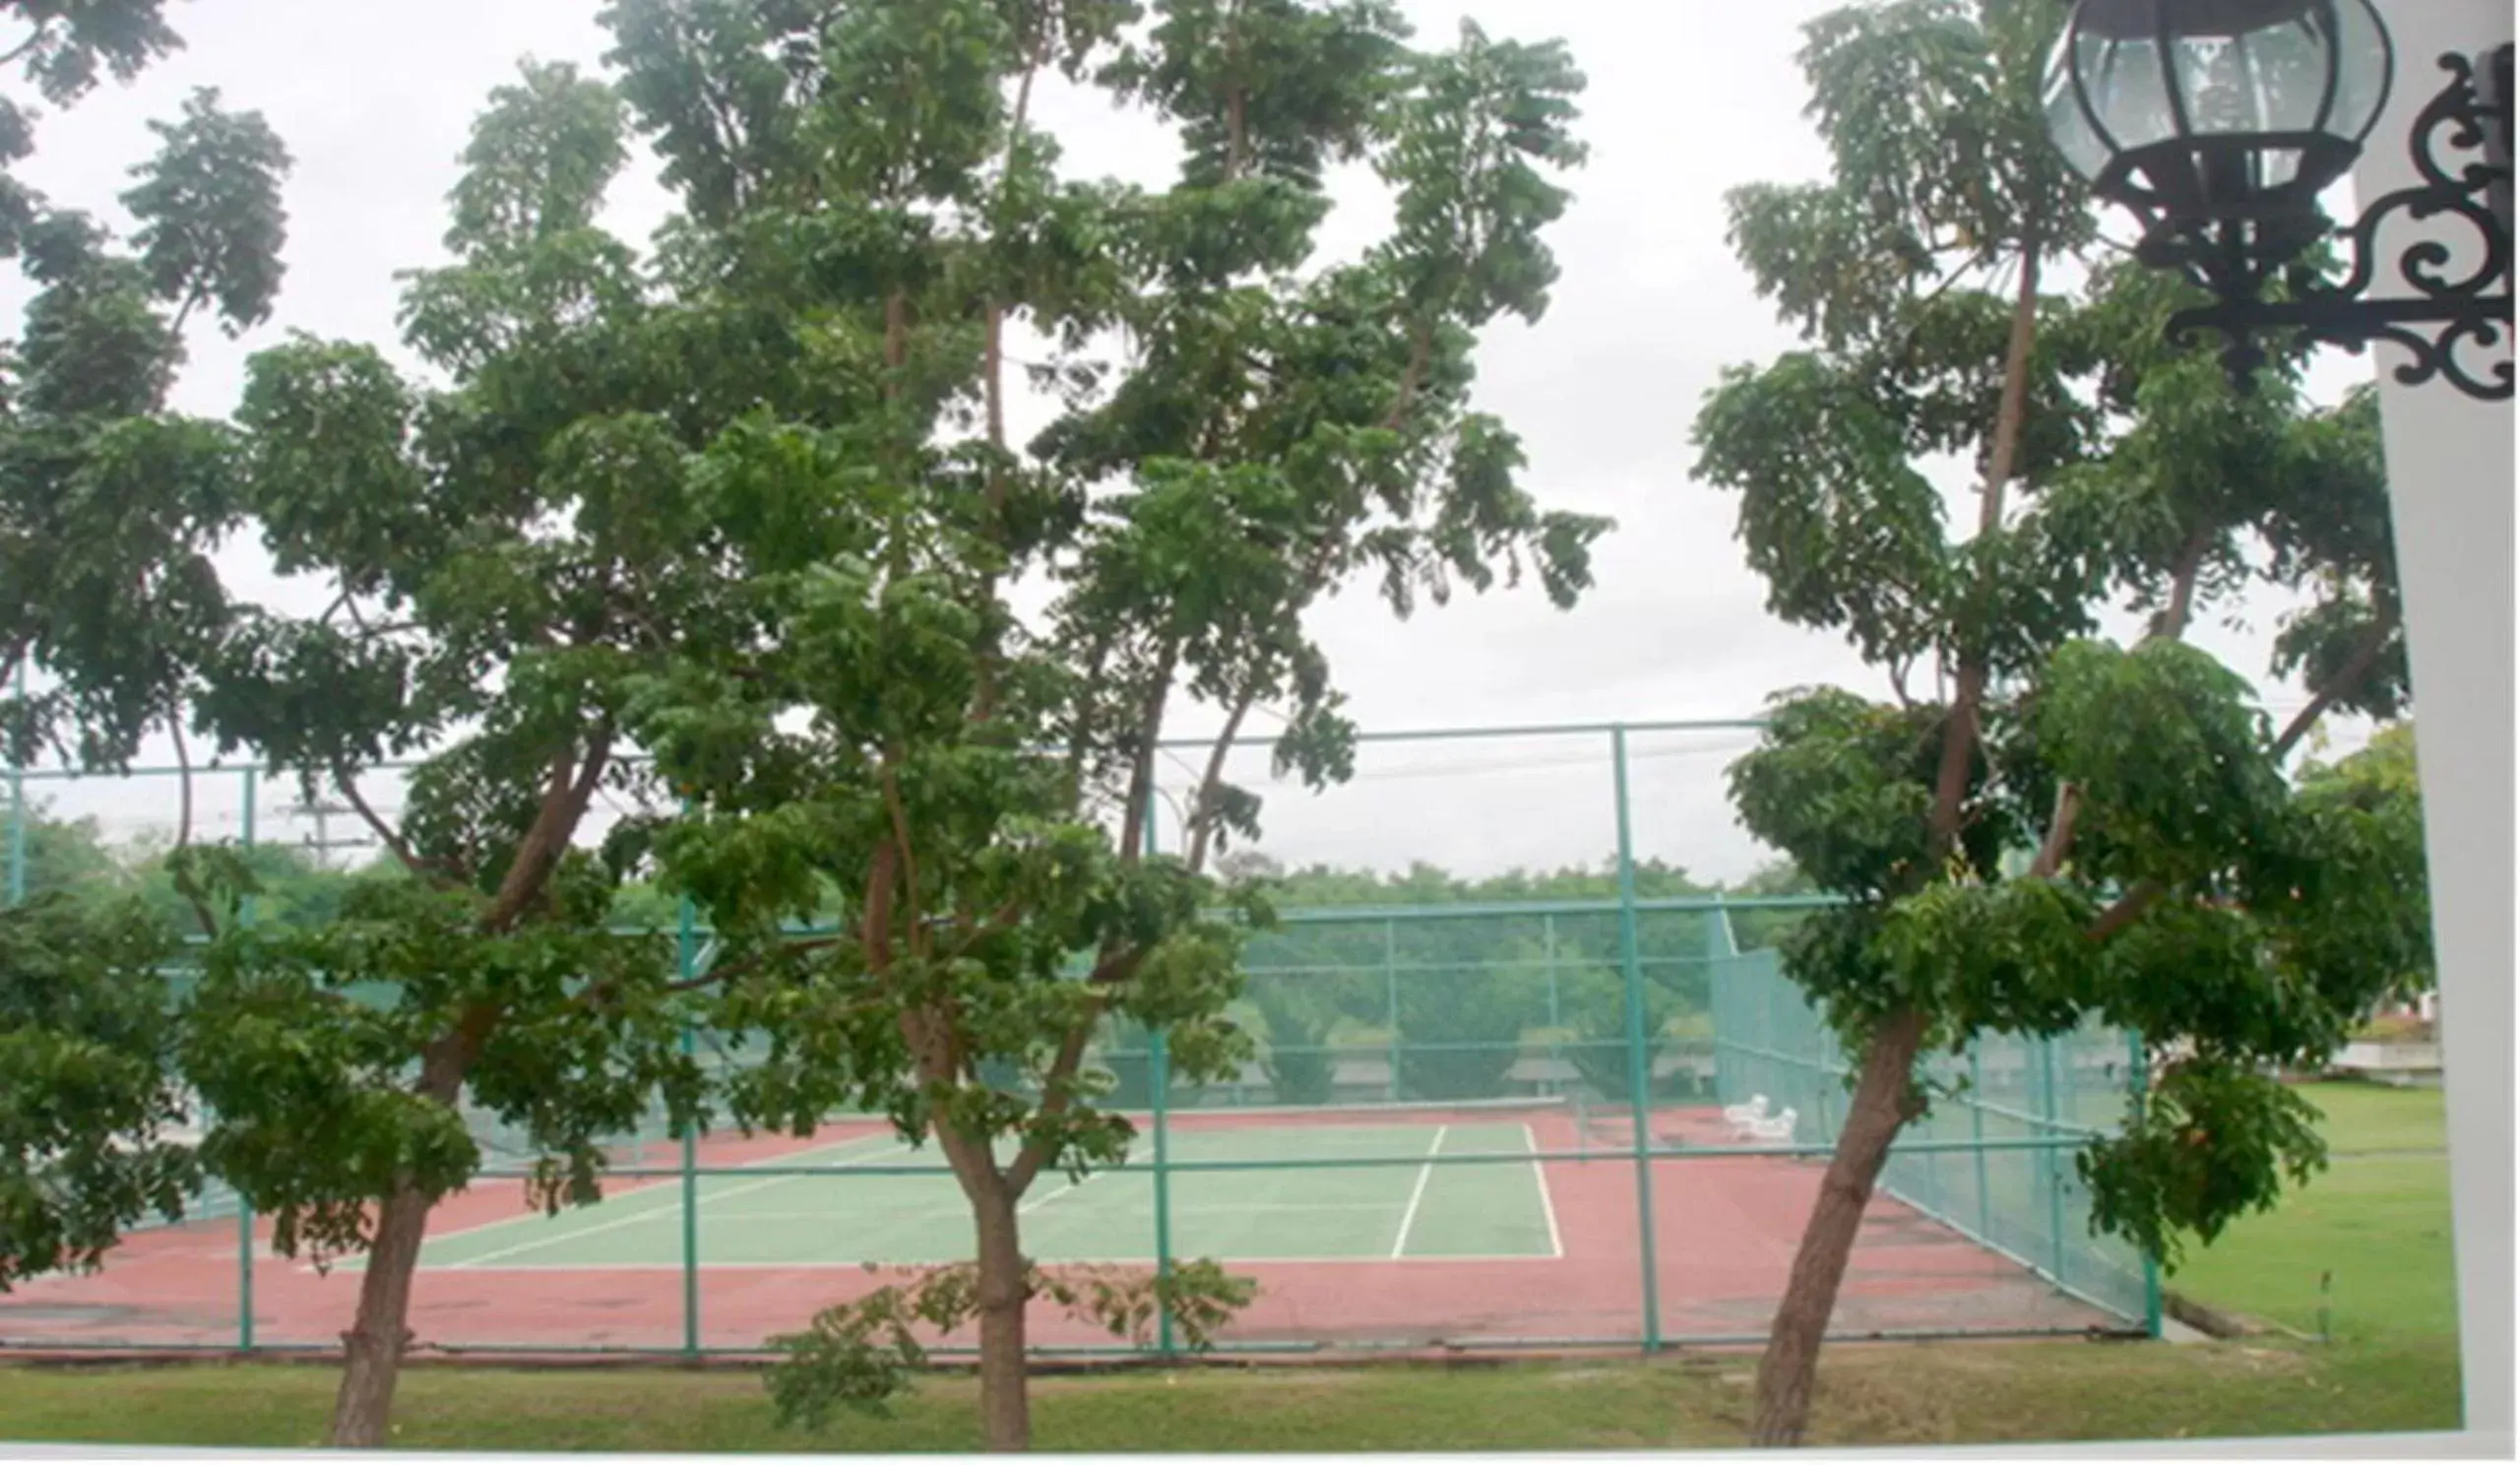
[162,66,733,1447]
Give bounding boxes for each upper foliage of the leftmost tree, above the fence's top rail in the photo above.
[0,0,289,776]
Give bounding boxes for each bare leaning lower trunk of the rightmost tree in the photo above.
[1749,1011,1925,1447]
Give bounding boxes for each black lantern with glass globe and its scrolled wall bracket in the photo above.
[2044,0,2512,399]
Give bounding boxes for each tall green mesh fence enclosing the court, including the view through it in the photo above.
[0,729,2157,1354]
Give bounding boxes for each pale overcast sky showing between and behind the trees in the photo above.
[0,0,2366,877]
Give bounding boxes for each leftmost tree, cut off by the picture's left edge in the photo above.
[0,0,287,1371]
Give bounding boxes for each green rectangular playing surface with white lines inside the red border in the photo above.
[406,1122,1562,1271]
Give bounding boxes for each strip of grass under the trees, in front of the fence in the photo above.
[0,1344,2457,1452]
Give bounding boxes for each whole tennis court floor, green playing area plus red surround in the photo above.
[0,1100,2124,1354]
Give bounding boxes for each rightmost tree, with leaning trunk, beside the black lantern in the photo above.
[1696,0,2404,1445]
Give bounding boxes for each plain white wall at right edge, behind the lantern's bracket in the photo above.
[2354,0,2512,1447]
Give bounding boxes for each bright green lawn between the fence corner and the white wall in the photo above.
[2170,1084,2460,1341]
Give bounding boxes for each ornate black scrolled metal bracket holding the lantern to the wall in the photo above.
[2170,45,2512,401]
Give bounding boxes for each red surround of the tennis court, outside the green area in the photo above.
[0,1107,2127,1352]
